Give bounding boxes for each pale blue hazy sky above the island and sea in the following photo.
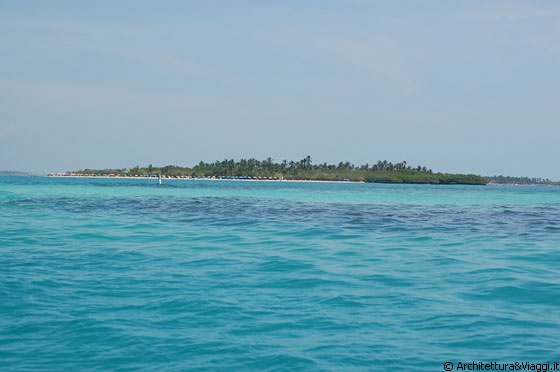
[0,0,560,180]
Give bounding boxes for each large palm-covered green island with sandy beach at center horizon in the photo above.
[72,156,488,185]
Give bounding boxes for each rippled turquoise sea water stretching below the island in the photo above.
[0,177,560,371]
